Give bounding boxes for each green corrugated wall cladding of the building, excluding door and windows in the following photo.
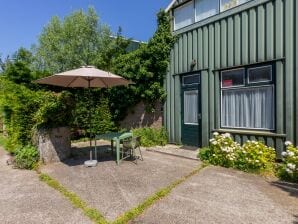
[165,0,298,156]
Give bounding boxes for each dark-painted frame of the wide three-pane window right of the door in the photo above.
[219,63,276,131]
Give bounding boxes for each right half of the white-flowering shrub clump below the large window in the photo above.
[235,141,276,173]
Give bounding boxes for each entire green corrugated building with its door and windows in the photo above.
[164,0,298,156]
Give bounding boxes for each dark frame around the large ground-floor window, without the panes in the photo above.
[218,62,277,132]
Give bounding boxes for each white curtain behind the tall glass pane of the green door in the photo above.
[184,90,198,124]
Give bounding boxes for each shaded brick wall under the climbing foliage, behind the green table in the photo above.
[120,102,163,130]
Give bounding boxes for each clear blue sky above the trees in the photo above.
[0,0,171,58]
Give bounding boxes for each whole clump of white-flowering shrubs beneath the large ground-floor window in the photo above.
[198,132,275,173]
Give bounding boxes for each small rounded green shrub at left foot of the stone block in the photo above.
[15,145,39,169]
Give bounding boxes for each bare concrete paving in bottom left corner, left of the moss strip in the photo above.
[0,148,91,224]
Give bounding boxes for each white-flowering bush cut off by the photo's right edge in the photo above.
[278,141,298,183]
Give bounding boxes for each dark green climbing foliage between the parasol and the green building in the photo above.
[110,11,175,120]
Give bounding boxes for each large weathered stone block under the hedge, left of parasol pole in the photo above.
[37,127,71,163]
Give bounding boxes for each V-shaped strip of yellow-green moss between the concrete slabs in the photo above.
[39,164,207,224]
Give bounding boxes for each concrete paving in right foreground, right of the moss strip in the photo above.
[131,167,298,224]
